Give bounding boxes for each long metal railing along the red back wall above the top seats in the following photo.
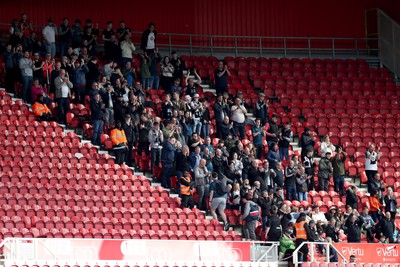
[0,23,379,58]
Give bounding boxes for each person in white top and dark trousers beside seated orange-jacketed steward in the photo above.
[54,69,73,123]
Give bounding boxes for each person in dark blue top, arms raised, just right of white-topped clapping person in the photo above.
[72,59,89,104]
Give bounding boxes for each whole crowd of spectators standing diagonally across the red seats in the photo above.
[3,14,399,255]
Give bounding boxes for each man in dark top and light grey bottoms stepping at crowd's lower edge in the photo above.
[210,172,229,231]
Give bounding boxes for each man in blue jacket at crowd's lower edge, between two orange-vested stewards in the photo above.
[161,137,176,188]
